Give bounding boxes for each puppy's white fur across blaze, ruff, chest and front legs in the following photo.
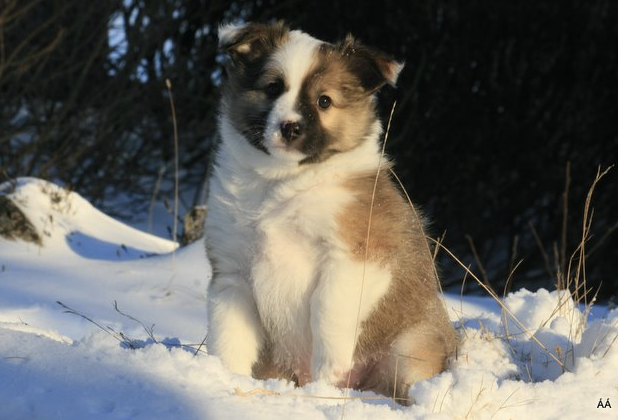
[206,27,391,383]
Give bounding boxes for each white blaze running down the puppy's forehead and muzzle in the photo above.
[264,31,322,161]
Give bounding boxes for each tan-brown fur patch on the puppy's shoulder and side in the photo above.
[338,170,456,381]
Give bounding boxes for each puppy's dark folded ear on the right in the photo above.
[339,35,404,93]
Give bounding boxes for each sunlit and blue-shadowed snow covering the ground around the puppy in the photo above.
[0,178,618,420]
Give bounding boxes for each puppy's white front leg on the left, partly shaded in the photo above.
[206,274,264,376]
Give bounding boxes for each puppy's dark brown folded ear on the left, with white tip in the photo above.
[218,21,289,65]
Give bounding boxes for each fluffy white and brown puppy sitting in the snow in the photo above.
[206,23,456,403]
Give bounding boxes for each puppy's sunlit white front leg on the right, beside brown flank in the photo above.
[311,256,391,386]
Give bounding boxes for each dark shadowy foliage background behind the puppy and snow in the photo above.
[0,0,618,298]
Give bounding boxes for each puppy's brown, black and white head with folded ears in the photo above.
[219,22,403,164]
